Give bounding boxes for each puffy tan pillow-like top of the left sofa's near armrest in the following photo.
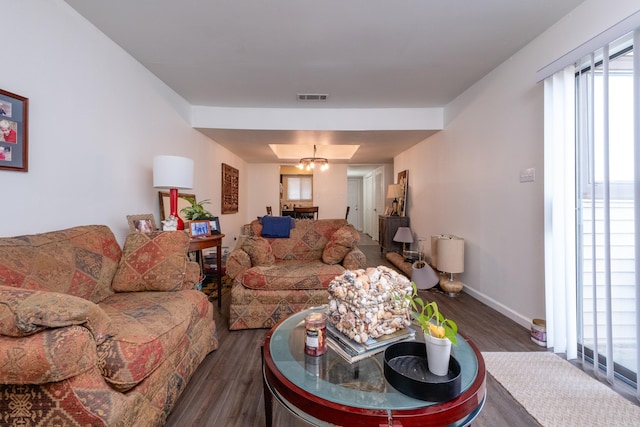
[0,286,111,344]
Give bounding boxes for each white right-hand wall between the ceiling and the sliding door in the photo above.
[394,0,638,326]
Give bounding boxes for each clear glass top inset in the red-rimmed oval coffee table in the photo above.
[269,307,478,410]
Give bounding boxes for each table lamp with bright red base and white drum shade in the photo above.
[153,156,193,230]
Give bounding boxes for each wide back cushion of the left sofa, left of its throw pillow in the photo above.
[0,225,122,303]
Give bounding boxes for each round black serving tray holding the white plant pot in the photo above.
[384,341,462,402]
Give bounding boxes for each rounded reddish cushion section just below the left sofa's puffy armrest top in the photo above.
[0,326,98,384]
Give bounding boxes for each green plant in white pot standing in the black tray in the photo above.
[406,282,458,375]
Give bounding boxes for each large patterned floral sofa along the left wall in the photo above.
[0,225,218,426]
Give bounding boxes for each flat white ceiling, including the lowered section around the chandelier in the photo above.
[65,0,583,171]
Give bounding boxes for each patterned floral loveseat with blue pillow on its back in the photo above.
[226,219,366,330]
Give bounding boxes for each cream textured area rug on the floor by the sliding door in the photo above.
[482,352,640,427]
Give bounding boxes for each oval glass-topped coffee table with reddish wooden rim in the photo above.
[263,307,486,427]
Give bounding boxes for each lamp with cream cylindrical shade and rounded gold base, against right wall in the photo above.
[436,235,464,296]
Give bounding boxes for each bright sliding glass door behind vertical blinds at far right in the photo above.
[576,36,640,383]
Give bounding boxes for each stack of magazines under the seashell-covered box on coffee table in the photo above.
[327,322,416,363]
